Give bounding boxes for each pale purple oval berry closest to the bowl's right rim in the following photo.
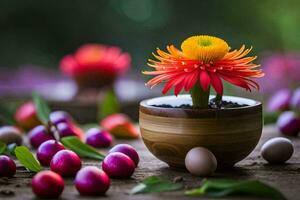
[267,89,292,112]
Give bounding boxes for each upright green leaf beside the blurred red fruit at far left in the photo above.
[32,92,50,124]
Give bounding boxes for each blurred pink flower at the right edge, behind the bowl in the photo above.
[258,52,300,94]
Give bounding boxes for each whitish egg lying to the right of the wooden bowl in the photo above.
[261,137,294,163]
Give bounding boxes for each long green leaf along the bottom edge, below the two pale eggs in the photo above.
[185,180,286,199]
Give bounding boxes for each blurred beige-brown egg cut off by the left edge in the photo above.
[0,126,22,145]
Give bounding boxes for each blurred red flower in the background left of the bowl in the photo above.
[60,44,131,88]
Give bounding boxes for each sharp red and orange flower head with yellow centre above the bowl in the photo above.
[143,35,264,95]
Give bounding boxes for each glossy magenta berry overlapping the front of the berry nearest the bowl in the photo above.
[102,152,135,178]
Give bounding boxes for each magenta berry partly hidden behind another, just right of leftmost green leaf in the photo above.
[36,140,65,166]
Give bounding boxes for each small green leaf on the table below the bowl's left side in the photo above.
[129,176,182,194]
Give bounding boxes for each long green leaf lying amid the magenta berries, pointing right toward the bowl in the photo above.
[61,136,105,160]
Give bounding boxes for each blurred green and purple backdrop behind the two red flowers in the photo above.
[0,0,300,121]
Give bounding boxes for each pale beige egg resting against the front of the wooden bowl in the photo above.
[185,147,217,176]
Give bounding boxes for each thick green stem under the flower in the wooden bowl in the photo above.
[190,83,210,108]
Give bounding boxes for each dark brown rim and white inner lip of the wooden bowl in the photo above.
[140,94,262,118]
